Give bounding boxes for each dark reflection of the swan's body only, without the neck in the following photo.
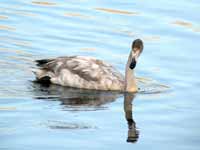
[33,84,122,111]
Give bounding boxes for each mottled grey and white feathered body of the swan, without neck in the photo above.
[36,56,124,91]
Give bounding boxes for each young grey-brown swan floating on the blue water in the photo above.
[34,39,143,92]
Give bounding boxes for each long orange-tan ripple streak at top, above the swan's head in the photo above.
[95,8,139,15]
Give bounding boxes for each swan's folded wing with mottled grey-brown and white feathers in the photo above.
[39,56,102,81]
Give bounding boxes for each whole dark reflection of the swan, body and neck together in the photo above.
[33,84,139,143]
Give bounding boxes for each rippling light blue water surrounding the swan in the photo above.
[0,0,200,150]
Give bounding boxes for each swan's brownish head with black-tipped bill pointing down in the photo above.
[129,39,144,69]
